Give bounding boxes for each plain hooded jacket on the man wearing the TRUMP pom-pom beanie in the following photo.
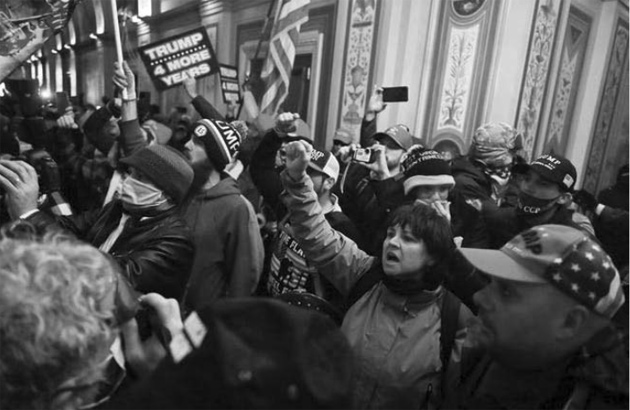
[182,176,264,309]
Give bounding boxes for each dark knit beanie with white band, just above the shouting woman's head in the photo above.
[401,145,455,195]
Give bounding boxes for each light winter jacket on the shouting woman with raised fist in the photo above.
[281,171,474,409]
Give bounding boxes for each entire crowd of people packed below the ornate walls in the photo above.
[0,63,629,409]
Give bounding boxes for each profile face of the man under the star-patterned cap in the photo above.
[468,277,561,361]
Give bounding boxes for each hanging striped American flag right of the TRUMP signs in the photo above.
[260,0,310,115]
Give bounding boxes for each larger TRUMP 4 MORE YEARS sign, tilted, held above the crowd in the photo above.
[138,27,219,90]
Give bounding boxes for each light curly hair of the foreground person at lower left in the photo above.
[0,235,115,409]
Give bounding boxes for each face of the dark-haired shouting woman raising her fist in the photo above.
[381,225,433,276]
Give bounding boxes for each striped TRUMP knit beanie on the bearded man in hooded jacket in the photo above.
[193,119,242,171]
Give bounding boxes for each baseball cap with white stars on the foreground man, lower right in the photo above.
[461,225,625,318]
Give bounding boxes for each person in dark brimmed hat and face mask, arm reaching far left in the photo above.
[0,145,194,298]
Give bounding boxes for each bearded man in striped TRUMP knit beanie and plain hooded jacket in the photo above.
[183,119,264,309]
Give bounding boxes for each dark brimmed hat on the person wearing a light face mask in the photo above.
[120,145,194,203]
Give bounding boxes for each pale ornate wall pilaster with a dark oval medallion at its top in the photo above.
[424,0,500,153]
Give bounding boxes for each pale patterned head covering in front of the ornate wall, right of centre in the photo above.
[468,122,516,166]
